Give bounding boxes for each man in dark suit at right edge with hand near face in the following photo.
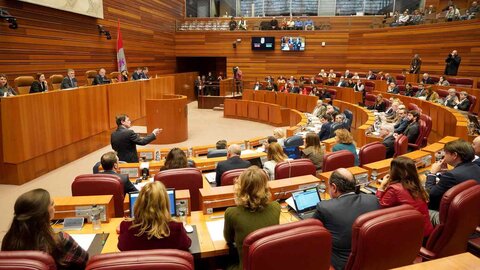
[425,139,480,226]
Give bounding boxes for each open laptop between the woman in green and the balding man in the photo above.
[292,187,321,219]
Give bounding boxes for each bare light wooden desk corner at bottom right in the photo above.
[395,252,480,270]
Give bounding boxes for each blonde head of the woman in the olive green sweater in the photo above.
[234,166,270,211]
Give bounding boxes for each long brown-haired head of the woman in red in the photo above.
[388,156,428,201]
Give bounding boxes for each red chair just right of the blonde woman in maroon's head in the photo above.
[155,168,203,211]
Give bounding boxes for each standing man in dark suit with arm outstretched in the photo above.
[110,114,162,163]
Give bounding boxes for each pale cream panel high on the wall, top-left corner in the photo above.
[20,0,103,19]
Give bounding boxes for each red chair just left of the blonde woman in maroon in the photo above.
[71,174,125,217]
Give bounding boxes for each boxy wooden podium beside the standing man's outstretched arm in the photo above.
[145,95,188,144]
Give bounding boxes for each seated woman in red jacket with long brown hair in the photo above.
[376,156,433,238]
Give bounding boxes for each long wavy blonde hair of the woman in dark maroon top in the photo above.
[130,181,172,239]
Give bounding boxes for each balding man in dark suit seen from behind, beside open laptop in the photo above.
[313,168,380,270]
